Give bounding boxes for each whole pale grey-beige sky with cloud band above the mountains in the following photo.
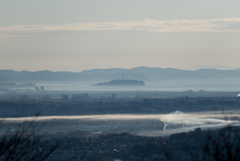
[0,0,240,72]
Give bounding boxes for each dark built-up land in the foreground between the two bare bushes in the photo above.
[38,128,224,161]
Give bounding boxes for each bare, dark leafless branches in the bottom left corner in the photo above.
[0,118,58,161]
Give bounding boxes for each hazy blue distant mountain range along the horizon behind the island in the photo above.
[0,67,240,83]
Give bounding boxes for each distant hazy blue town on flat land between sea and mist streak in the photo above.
[0,87,240,117]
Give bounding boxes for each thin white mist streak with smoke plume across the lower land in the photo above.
[3,111,240,135]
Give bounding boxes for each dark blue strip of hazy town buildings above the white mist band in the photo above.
[0,91,240,117]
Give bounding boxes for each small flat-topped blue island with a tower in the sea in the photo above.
[93,79,145,86]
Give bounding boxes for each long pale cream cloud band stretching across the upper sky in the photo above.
[0,17,240,32]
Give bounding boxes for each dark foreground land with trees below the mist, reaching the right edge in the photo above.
[43,126,240,161]
